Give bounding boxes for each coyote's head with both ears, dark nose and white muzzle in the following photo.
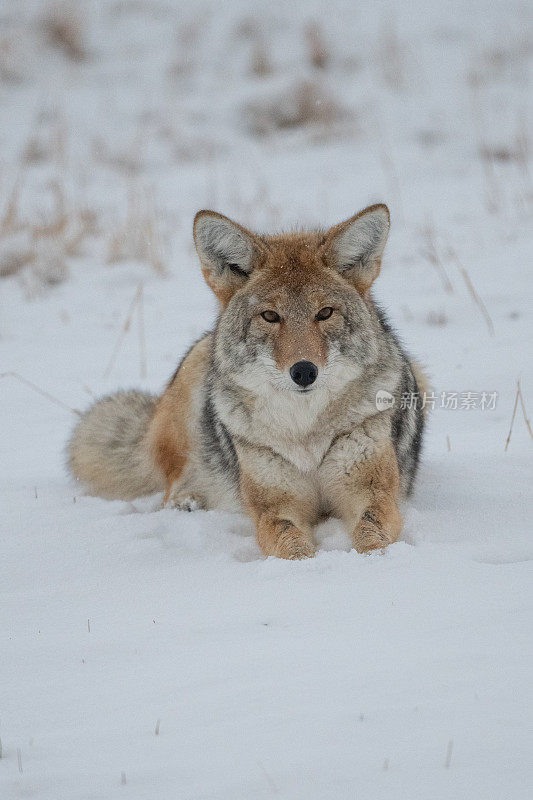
[194,205,389,396]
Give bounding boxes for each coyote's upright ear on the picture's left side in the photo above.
[193,211,264,303]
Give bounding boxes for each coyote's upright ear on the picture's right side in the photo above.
[323,203,389,294]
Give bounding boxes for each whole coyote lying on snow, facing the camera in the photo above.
[68,204,424,559]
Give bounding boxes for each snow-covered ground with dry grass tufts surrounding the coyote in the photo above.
[0,0,533,800]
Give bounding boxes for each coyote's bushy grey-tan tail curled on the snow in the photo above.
[67,391,164,500]
